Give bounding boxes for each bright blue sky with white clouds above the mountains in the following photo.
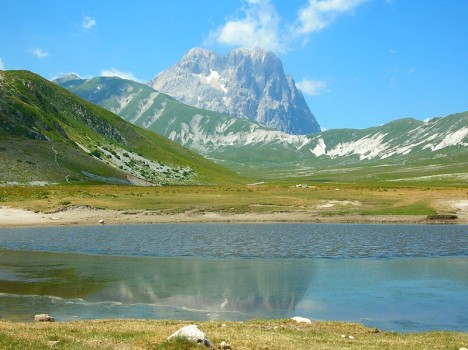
[0,0,468,129]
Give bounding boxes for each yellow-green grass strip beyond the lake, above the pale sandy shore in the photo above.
[0,184,468,216]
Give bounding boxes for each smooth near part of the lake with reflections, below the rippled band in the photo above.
[0,250,468,331]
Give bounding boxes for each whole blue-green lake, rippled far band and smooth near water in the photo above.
[0,224,468,332]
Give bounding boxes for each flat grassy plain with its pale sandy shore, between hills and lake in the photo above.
[0,185,468,227]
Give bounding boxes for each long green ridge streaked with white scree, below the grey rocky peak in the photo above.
[56,77,468,183]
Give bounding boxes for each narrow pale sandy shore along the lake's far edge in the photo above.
[0,207,468,227]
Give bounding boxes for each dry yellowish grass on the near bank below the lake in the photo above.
[0,320,468,350]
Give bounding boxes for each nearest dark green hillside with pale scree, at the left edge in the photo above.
[0,71,242,185]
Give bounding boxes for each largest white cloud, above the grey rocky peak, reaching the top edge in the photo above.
[207,0,368,52]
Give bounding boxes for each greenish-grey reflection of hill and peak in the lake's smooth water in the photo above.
[0,251,314,319]
